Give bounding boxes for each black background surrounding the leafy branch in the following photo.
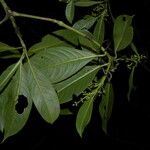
[0,0,150,150]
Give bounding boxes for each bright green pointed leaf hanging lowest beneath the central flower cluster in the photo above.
[76,99,93,137]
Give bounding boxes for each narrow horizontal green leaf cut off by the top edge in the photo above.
[75,0,102,7]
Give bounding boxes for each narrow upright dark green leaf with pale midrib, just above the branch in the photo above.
[93,15,105,45]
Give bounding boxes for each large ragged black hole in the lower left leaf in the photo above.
[15,95,28,114]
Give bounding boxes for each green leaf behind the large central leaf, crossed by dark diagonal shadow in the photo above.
[28,29,78,55]
